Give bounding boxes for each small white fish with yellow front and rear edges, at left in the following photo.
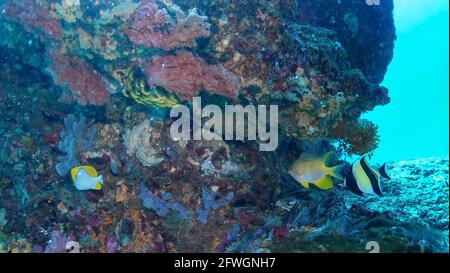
[70,166,103,191]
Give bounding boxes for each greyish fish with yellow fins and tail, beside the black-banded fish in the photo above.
[289,152,345,190]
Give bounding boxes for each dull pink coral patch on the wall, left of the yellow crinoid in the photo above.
[49,47,110,105]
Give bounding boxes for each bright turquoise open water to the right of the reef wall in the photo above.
[365,0,449,162]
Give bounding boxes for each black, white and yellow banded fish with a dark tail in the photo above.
[344,154,391,196]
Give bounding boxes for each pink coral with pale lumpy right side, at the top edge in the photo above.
[125,0,210,50]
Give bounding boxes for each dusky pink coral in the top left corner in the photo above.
[3,0,62,40]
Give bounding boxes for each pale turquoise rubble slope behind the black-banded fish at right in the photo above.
[345,158,449,232]
